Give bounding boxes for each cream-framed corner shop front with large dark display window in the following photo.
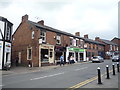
[39,44,54,66]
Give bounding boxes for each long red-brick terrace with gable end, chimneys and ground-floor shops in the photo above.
[12,15,103,67]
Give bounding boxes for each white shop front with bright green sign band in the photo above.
[66,47,86,62]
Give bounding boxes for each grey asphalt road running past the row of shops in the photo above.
[2,60,116,88]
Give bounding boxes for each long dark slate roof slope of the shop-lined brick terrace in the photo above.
[28,20,105,45]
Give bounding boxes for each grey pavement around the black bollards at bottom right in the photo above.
[80,71,120,90]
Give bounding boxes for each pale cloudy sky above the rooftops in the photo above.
[0,0,119,40]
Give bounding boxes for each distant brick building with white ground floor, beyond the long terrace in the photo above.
[95,37,118,59]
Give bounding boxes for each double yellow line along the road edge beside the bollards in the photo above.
[66,70,112,90]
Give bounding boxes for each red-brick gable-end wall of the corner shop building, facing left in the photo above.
[12,22,40,66]
